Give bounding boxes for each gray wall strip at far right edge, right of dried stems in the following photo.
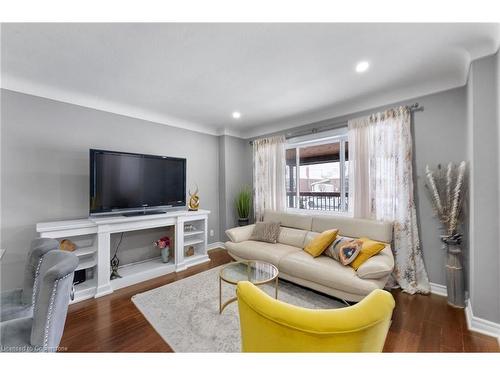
[468,53,500,323]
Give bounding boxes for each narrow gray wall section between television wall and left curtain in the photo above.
[219,136,252,241]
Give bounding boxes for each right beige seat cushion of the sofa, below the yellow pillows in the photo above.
[278,251,378,295]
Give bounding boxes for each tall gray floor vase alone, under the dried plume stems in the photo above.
[446,244,465,308]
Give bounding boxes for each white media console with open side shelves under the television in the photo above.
[36,210,210,302]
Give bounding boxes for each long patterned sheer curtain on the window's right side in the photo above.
[348,107,430,294]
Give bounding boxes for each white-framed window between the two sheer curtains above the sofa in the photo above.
[286,129,349,212]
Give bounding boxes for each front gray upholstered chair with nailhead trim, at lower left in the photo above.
[0,250,78,352]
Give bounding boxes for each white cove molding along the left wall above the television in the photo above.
[1,74,219,136]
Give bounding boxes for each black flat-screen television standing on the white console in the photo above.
[89,149,186,215]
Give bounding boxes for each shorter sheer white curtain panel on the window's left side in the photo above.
[253,136,286,221]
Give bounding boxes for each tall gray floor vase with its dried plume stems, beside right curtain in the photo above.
[425,161,466,307]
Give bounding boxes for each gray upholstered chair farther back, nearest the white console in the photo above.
[0,238,59,322]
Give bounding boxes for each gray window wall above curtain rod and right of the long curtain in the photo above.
[252,87,467,285]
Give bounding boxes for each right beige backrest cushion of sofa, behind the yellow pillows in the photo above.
[311,215,392,243]
